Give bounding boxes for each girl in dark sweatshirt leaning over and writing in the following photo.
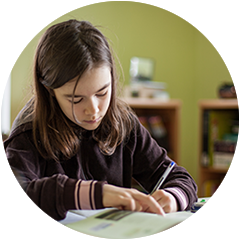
[2,20,197,220]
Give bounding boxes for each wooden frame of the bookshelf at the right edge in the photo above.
[198,99,239,197]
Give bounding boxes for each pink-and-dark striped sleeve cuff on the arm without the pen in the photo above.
[74,180,106,209]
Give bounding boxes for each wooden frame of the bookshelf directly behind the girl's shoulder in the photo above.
[123,98,181,164]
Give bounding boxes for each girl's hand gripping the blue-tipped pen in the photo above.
[152,190,178,213]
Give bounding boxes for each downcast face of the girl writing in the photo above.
[54,66,112,130]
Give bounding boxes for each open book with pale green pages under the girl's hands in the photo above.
[64,209,195,239]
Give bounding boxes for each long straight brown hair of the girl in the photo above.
[30,20,135,161]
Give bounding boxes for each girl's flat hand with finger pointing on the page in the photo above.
[103,184,164,215]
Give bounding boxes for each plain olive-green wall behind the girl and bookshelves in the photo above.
[11,1,239,183]
